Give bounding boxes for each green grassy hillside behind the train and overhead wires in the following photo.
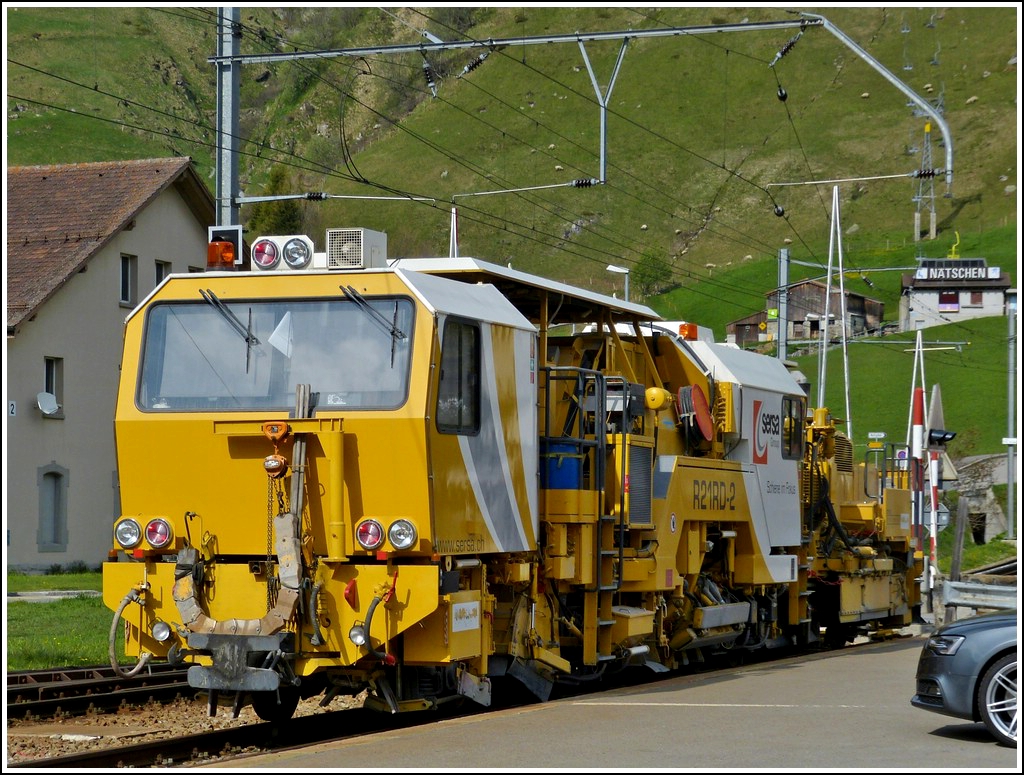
[4,6,1020,454]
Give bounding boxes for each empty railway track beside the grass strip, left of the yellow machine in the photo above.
[7,664,196,719]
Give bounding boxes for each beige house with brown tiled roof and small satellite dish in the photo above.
[4,158,216,570]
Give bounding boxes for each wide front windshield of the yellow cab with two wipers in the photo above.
[136,292,414,412]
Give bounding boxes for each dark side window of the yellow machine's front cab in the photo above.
[436,320,480,435]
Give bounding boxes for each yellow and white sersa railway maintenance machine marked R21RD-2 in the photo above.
[103,229,923,719]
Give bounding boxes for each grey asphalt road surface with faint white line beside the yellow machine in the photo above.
[205,635,1021,773]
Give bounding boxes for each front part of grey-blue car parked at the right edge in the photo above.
[910,610,1017,747]
